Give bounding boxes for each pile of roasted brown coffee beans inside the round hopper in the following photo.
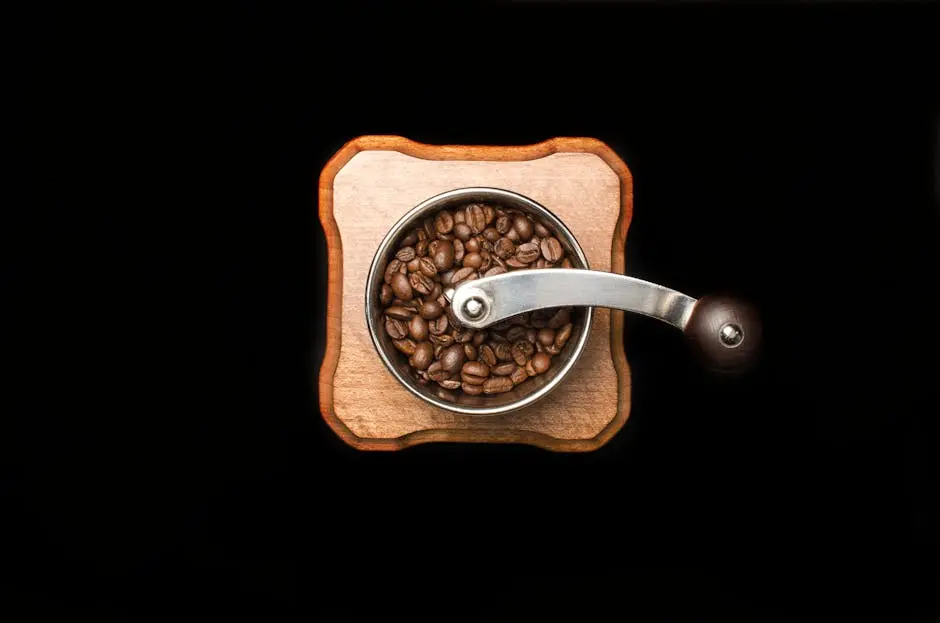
[379,203,572,396]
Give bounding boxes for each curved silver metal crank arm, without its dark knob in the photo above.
[452,268,697,330]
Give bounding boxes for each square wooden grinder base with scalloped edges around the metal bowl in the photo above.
[320,136,633,452]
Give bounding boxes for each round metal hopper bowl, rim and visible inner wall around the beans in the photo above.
[365,188,593,415]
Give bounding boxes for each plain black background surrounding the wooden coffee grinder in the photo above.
[18,3,940,621]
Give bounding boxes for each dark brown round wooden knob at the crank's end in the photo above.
[685,296,761,373]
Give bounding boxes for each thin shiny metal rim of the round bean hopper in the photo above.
[365,186,594,416]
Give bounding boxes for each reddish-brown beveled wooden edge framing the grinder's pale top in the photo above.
[319,135,633,452]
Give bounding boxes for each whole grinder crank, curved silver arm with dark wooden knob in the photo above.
[444,268,761,372]
